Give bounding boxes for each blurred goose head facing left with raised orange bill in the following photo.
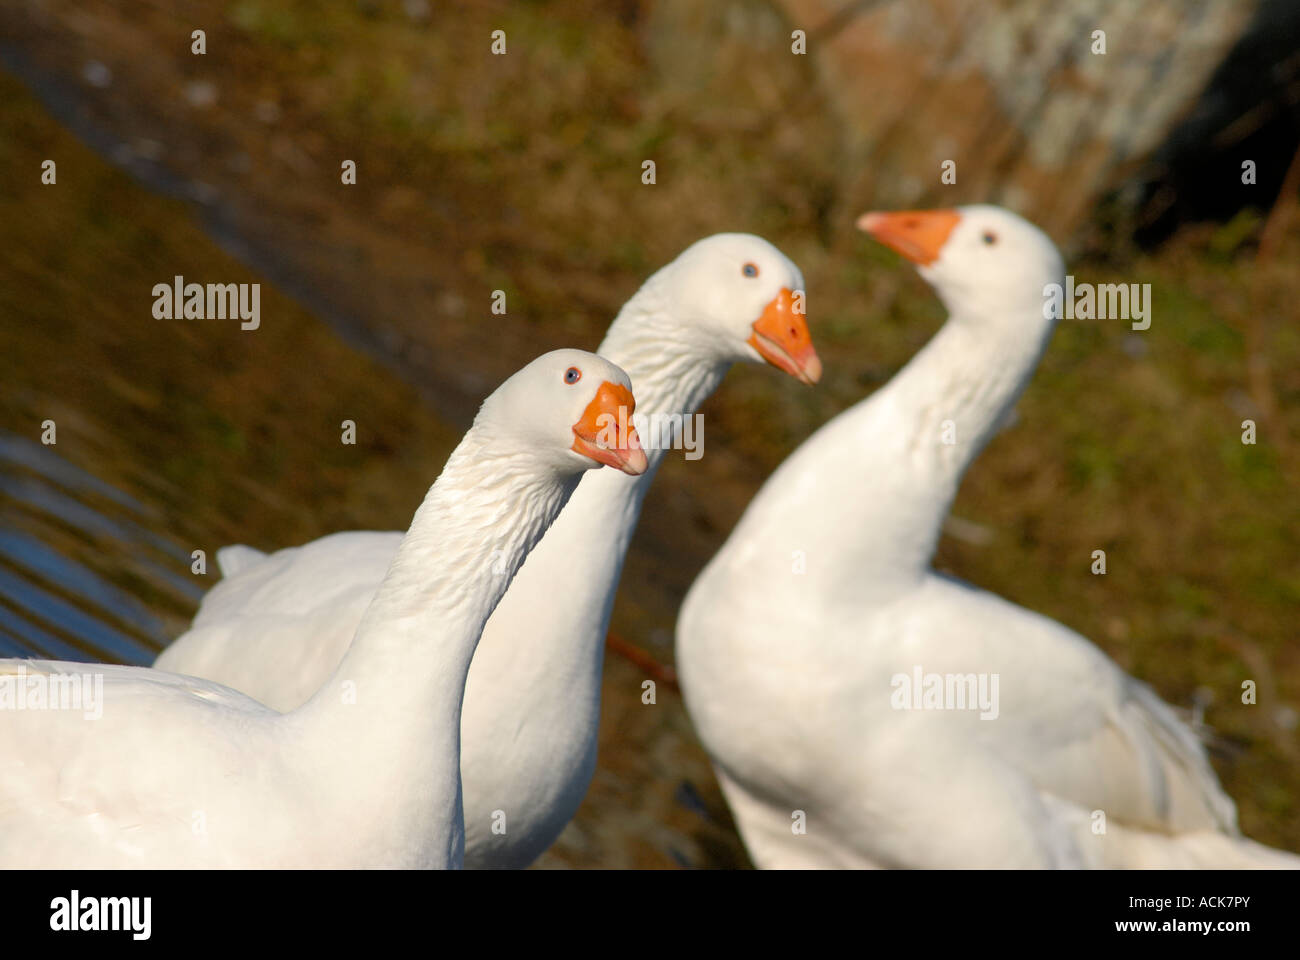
[858,204,1065,319]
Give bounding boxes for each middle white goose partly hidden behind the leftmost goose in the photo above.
[157,234,822,868]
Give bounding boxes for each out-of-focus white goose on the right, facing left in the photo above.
[677,206,1300,868]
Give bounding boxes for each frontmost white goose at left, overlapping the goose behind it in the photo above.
[0,350,646,868]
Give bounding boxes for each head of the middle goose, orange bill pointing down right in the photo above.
[664,233,822,384]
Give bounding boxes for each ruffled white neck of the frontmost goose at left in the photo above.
[295,424,581,738]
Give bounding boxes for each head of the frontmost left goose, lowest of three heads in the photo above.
[475,350,646,476]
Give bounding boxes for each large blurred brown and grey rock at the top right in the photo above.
[777,0,1257,237]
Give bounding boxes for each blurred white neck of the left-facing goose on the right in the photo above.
[735,299,1053,597]
